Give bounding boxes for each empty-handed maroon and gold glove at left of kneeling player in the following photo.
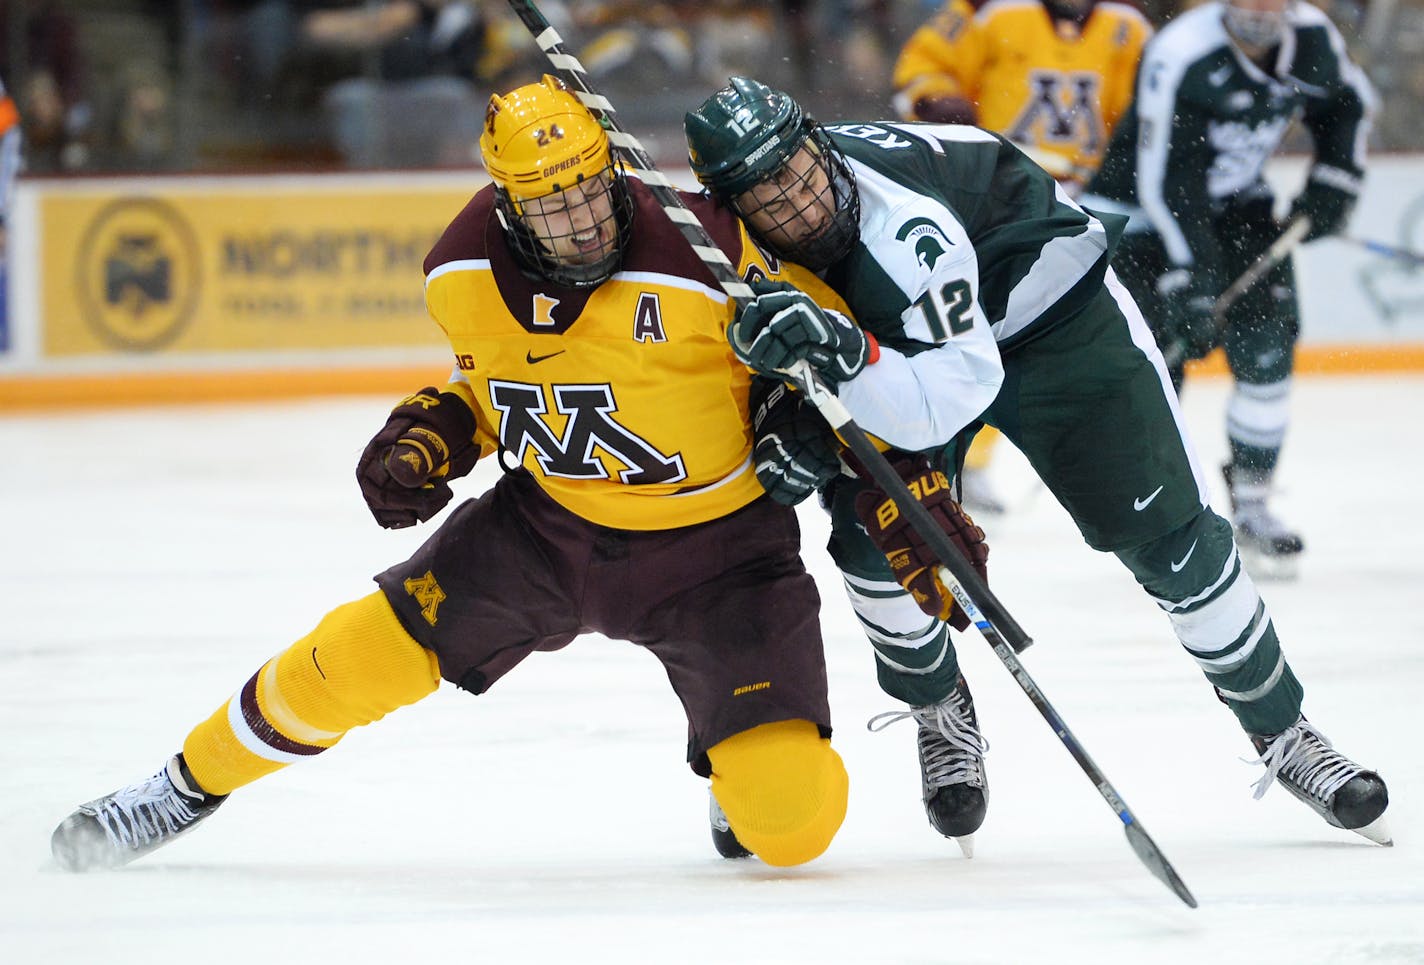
[356,386,481,529]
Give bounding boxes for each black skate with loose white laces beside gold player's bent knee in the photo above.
[866,676,988,858]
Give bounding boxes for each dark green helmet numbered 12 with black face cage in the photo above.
[682,77,860,270]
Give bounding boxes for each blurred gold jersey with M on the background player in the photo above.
[893,0,1152,182]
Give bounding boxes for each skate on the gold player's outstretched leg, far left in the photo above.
[50,754,228,871]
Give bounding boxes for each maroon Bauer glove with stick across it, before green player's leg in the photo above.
[856,454,988,631]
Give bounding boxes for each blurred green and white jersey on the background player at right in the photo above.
[1081,0,1373,272]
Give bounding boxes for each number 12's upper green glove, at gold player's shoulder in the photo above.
[728,280,874,389]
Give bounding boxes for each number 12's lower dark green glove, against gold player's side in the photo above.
[750,379,840,505]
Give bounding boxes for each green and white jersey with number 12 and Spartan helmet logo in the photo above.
[826,122,1121,450]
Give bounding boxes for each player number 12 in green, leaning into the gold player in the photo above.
[684,77,1390,859]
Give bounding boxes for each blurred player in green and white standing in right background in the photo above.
[1081,0,1371,576]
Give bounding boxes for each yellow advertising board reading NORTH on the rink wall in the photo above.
[38,176,483,359]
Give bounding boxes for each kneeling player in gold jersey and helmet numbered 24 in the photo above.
[51,77,847,870]
